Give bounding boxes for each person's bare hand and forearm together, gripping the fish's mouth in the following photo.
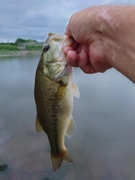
[65,5,135,83]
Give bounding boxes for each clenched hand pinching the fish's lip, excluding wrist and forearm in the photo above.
[64,7,112,74]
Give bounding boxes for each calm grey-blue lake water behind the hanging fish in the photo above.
[0,55,135,180]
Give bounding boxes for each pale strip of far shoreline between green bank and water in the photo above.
[0,50,41,58]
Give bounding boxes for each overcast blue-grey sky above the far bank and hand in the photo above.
[0,0,135,42]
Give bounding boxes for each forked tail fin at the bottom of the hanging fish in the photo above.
[51,149,73,171]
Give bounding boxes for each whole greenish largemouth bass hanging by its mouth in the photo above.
[34,33,80,171]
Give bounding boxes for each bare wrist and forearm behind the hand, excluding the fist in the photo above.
[98,5,135,83]
